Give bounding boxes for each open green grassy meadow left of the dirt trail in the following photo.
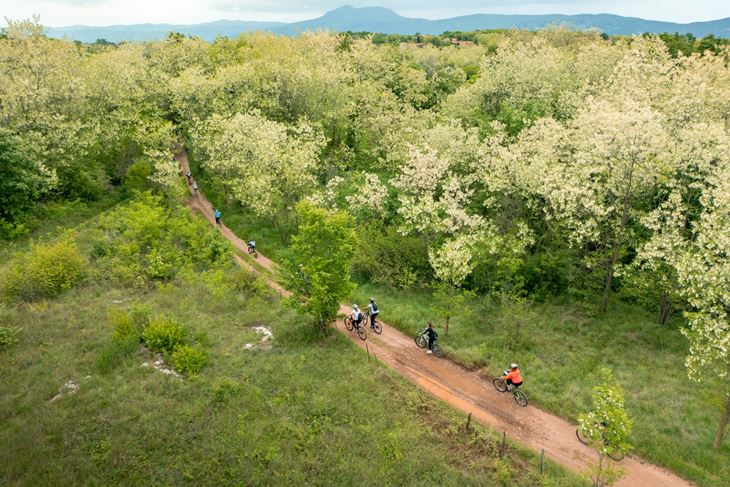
[0,201,585,486]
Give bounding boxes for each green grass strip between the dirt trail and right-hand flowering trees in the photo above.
[353,285,730,487]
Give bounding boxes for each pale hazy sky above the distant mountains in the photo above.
[0,0,730,27]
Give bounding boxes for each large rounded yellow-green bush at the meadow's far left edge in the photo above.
[2,239,86,301]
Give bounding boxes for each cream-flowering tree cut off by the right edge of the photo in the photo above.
[638,122,730,448]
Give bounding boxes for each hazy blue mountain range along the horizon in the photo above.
[49,6,730,42]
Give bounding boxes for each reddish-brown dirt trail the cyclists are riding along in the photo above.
[175,151,694,487]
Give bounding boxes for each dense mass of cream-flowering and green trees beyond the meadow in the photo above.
[0,15,730,480]
